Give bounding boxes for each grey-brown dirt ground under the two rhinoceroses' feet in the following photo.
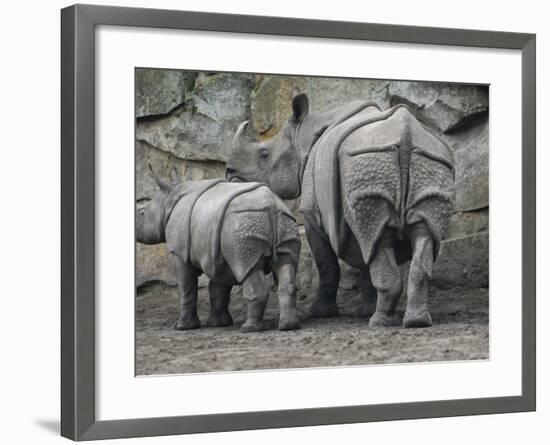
[136,284,489,375]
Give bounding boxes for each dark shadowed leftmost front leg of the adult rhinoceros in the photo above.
[304,213,340,318]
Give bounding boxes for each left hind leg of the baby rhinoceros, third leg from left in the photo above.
[241,267,269,332]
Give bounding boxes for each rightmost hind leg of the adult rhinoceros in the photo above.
[403,223,433,328]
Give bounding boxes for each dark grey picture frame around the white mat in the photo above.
[61,5,536,440]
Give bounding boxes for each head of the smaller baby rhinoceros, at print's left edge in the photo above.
[136,164,178,244]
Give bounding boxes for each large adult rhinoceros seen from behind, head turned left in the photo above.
[226,88,454,327]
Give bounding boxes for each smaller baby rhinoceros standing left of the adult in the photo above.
[136,165,300,332]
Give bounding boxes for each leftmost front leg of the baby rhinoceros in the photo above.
[174,256,201,331]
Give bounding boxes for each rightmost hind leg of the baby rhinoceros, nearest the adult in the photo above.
[273,260,300,331]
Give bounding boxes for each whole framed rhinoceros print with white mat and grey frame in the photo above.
[61,5,536,440]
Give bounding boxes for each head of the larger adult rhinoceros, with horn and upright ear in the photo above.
[225,88,309,199]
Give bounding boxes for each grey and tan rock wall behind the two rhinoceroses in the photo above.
[136,69,489,294]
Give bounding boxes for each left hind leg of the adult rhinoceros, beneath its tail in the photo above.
[369,230,402,327]
